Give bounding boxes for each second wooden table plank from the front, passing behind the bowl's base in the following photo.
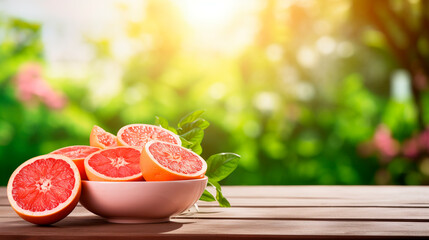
[0,206,429,222]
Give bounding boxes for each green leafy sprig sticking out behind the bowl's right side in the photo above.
[155,110,240,207]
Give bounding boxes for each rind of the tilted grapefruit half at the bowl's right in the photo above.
[140,140,207,181]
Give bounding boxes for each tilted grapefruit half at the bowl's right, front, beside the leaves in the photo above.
[140,141,207,181]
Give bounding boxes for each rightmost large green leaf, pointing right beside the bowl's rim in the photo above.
[206,153,241,182]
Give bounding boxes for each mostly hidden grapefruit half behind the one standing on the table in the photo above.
[51,145,101,180]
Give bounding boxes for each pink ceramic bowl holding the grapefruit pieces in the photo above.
[80,177,207,223]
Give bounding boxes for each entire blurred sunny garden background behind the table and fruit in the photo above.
[0,0,429,185]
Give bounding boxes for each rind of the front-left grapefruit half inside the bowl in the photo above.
[84,146,143,182]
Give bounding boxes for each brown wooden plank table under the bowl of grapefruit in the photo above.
[0,186,429,240]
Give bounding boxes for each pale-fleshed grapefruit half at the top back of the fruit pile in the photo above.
[117,124,182,149]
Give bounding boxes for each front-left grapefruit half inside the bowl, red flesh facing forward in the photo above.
[84,147,143,181]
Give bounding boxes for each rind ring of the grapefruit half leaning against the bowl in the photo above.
[7,154,81,225]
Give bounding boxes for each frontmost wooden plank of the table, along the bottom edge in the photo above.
[0,216,429,240]
